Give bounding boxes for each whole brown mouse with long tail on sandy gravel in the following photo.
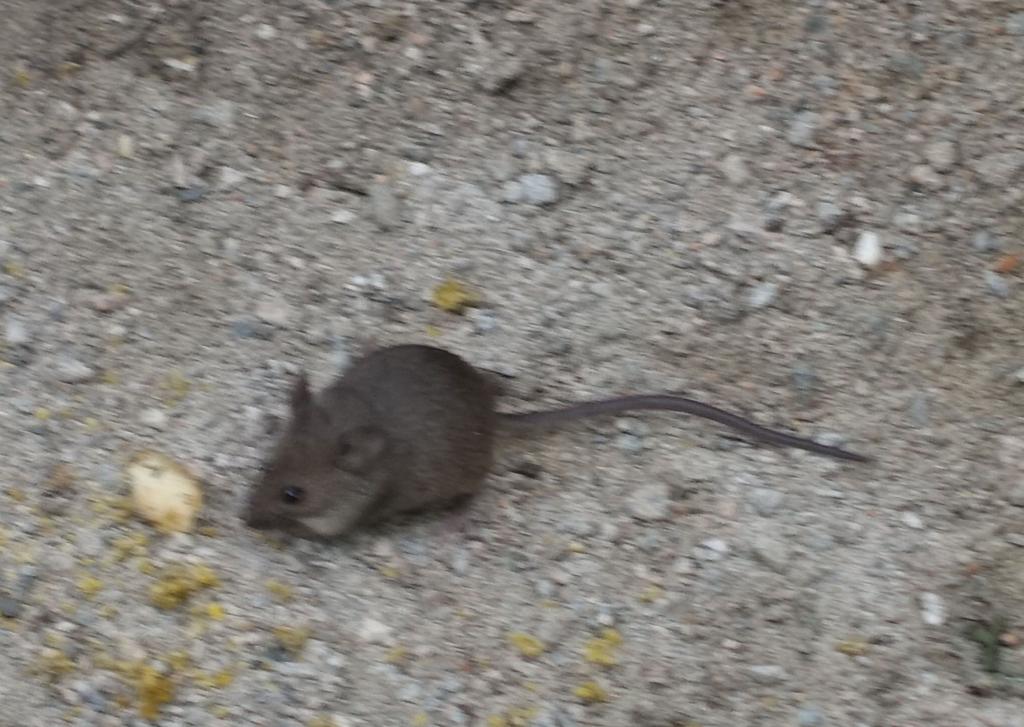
[242,344,870,540]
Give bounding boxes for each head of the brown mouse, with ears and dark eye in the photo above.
[244,374,389,538]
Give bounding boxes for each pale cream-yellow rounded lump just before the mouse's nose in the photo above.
[127,452,203,532]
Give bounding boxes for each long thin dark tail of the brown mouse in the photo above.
[499,394,870,462]
